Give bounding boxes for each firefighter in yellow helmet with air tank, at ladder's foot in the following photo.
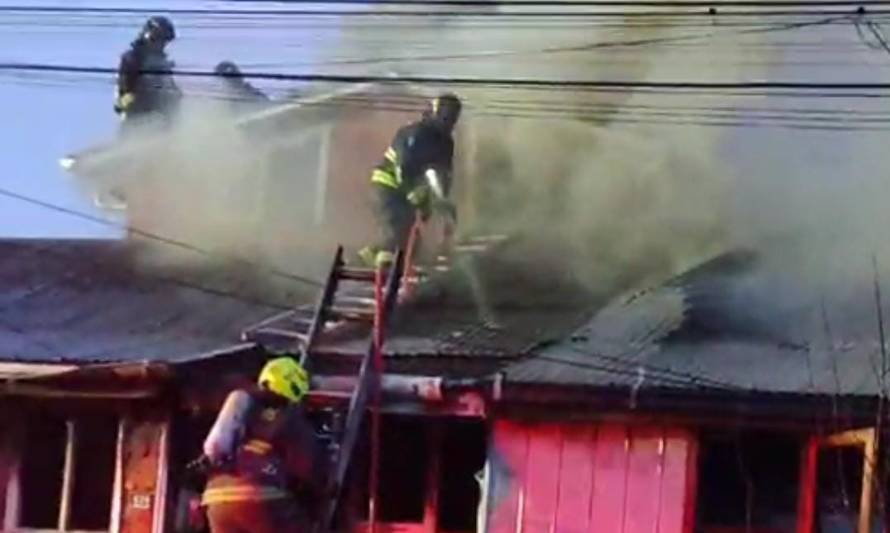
[202,357,327,533]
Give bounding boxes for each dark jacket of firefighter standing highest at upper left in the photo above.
[115,40,182,115]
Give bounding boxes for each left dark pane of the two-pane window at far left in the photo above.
[19,416,68,529]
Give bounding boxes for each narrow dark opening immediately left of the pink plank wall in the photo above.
[438,422,487,531]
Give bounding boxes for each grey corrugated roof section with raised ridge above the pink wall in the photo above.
[505,253,881,395]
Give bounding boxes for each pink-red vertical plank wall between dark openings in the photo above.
[487,421,697,533]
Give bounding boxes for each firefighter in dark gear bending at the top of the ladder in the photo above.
[358,93,461,266]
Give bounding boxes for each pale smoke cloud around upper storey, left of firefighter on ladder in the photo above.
[78,92,333,304]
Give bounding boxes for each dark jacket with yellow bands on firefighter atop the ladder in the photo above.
[371,119,454,205]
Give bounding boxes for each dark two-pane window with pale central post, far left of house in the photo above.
[18,415,118,531]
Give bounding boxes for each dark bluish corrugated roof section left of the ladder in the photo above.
[0,240,304,363]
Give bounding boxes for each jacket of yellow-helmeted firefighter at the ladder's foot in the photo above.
[202,390,327,505]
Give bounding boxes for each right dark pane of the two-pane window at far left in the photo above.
[68,416,118,531]
